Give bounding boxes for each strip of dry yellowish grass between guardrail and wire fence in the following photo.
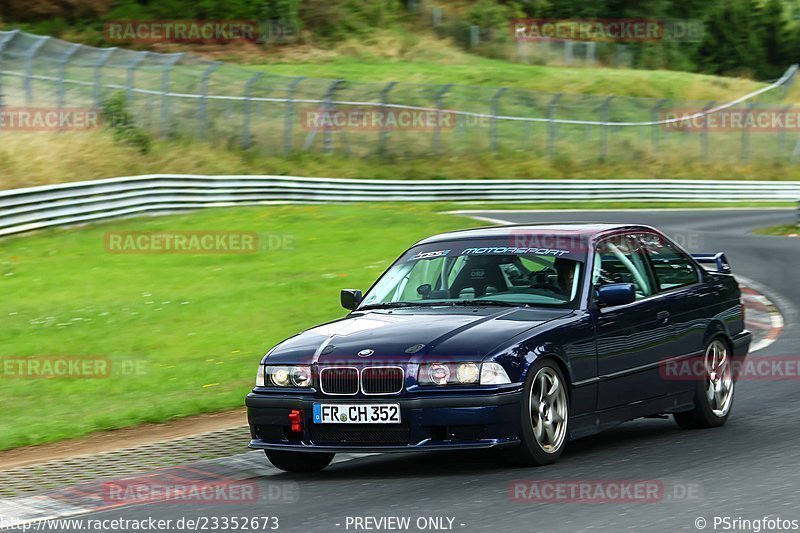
[0,131,800,189]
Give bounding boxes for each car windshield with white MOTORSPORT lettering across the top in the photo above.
[360,235,586,309]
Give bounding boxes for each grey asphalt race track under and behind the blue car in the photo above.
[6,210,800,532]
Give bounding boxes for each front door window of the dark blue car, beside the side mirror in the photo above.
[593,235,654,300]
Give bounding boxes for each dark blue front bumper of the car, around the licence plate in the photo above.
[246,389,522,452]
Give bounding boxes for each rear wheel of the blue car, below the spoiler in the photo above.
[673,337,736,429]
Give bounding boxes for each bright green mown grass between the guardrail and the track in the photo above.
[0,203,792,449]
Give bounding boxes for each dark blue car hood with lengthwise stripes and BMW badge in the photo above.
[267,307,572,364]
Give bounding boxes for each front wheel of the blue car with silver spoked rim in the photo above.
[504,359,569,466]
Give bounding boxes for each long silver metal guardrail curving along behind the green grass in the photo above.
[0,174,800,236]
